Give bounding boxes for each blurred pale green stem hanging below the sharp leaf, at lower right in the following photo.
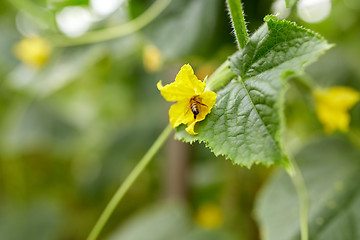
[288,160,309,240]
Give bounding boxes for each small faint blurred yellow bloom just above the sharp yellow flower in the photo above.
[143,45,162,73]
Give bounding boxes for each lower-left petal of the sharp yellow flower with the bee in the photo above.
[169,100,194,128]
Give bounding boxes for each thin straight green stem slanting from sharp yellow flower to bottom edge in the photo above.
[87,124,172,240]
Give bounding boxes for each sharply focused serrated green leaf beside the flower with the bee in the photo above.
[175,16,330,167]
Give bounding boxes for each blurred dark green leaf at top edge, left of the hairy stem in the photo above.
[144,0,222,59]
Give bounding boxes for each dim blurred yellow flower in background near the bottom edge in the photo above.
[195,203,224,229]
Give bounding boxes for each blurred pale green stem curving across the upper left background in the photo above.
[50,0,171,47]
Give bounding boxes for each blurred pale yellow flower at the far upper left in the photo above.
[14,37,51,68]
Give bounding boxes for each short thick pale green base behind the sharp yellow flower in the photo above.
[206,61,236,92]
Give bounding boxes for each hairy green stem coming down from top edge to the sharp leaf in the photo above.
[227,0,249,49]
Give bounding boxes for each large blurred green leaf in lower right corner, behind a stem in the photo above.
[256,138,360,240]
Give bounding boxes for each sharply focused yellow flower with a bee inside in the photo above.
[157,64,216,135]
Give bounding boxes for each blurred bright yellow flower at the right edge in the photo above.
[314,87,360,133]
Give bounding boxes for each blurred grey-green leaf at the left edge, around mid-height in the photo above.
[2,102,77,155]
